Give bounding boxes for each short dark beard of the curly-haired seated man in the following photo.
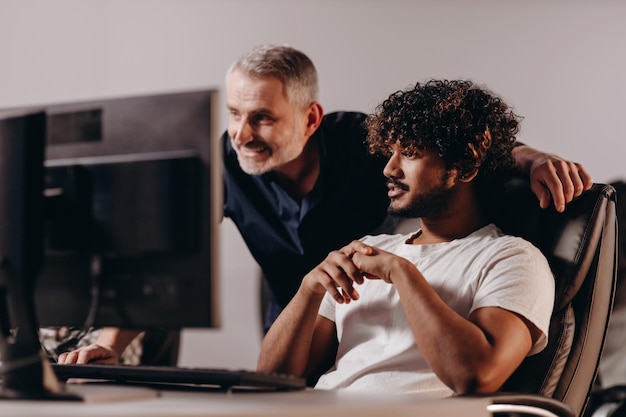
[387,174,453,218]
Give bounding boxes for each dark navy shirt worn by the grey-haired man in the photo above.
[222,112,389,327]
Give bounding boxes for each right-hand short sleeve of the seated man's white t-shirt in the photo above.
[470,238,554,355]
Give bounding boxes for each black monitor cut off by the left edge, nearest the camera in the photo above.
[0,112,46,397]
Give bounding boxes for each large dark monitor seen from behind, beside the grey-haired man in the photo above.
[0,90,223,398]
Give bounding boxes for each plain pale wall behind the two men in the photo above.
[0,0,626,367]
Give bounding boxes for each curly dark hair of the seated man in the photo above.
[365,80,521,214]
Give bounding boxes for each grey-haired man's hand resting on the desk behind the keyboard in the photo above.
[57,327,141,364]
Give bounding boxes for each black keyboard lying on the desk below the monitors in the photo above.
[52,363,306,391]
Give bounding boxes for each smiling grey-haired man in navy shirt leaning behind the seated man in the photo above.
[59,45,592,363]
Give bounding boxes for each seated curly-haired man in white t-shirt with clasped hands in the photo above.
[258,81,554,396]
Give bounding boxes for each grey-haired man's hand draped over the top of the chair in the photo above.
[513,145,593,212]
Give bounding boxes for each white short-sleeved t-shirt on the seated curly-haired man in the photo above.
[316,224,554,397]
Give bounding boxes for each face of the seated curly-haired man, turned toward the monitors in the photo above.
[383,144,455,217]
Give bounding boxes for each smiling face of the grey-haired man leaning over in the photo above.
[226,70,309,175]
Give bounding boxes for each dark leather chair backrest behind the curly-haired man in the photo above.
[496,178,617,416]
